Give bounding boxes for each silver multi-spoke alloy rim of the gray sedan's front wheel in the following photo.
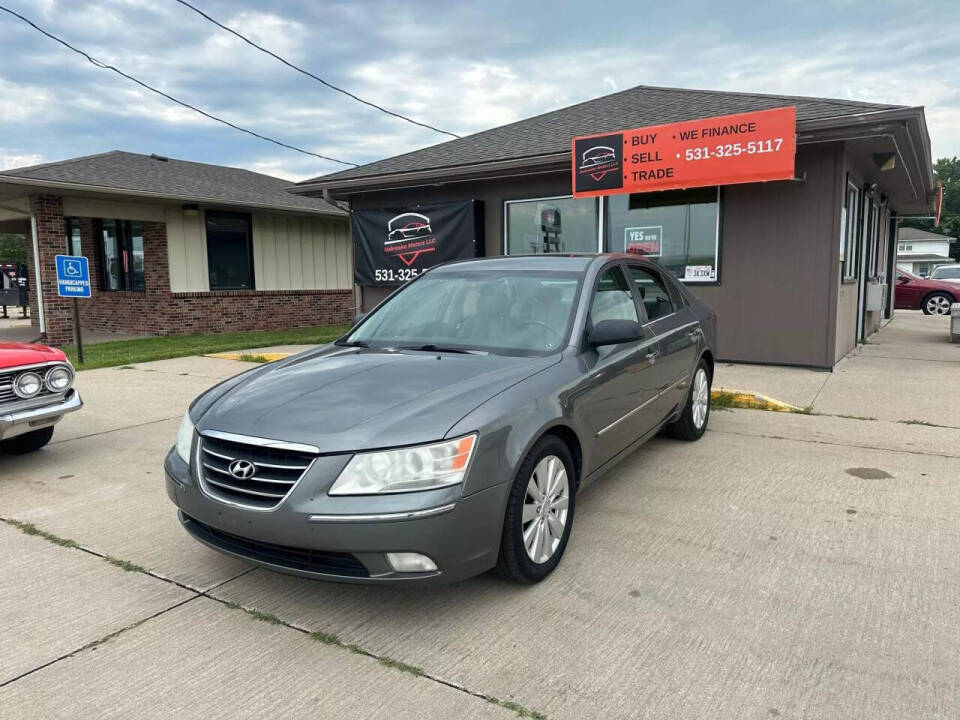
[521,455,570,564]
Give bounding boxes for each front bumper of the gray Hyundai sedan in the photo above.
[164,450,510,584]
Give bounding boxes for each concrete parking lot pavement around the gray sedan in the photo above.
[0,313,960,720]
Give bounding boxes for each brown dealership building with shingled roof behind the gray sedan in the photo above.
[294,86,934,368]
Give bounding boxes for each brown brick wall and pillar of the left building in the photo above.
[30,196,354,345]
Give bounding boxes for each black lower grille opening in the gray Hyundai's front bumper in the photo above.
[183,515,370,577]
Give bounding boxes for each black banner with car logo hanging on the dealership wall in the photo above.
[350,200,483,287]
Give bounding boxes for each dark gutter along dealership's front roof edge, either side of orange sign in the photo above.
[290,107,923,197]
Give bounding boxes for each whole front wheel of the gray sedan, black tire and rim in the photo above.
[495,435,577,585]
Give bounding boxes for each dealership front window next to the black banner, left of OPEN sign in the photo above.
[504,197,600,255]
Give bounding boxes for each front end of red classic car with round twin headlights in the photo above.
[0,341,83,453]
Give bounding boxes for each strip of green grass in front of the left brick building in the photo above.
[64,326,347,370]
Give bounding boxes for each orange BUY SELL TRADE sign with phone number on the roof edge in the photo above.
[572,107,797,197]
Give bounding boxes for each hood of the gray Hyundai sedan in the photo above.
[194,346,560,453]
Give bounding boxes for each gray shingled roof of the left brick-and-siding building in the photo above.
[0,150,346,215]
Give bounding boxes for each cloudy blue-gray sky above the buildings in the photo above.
[0,0,960,180]
